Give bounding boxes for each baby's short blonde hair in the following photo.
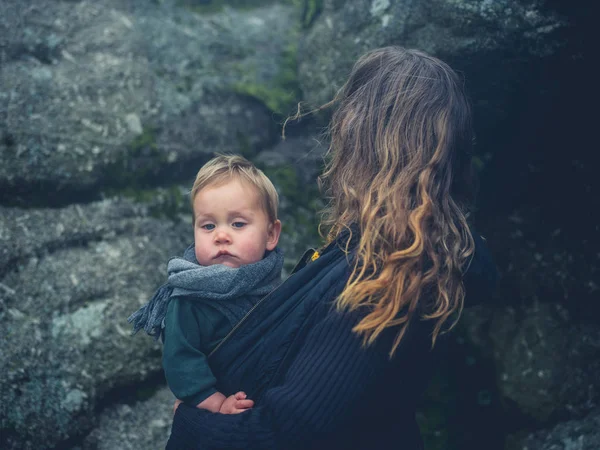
[190,155,279,222]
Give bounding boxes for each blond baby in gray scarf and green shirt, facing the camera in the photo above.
[129,156,283,414]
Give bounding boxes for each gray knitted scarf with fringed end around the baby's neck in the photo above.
[127,245,283,339]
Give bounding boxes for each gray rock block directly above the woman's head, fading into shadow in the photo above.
[298,0,566,106]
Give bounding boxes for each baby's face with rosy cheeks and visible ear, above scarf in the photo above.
[194,179,281,267]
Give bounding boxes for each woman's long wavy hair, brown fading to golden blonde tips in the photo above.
[319,47,475,357]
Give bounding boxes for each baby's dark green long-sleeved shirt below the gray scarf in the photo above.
[163,298,234,406]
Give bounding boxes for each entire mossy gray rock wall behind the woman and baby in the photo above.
[0,0,600,450]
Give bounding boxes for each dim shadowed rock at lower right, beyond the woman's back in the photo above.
[462,302,600,425]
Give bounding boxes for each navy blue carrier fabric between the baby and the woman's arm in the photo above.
[208,242,350,402]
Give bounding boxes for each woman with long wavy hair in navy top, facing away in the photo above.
[167,47,496,450]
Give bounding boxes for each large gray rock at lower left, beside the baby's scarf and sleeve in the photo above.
[0,200,190,449]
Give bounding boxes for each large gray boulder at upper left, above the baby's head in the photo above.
[0,0,295,199]
